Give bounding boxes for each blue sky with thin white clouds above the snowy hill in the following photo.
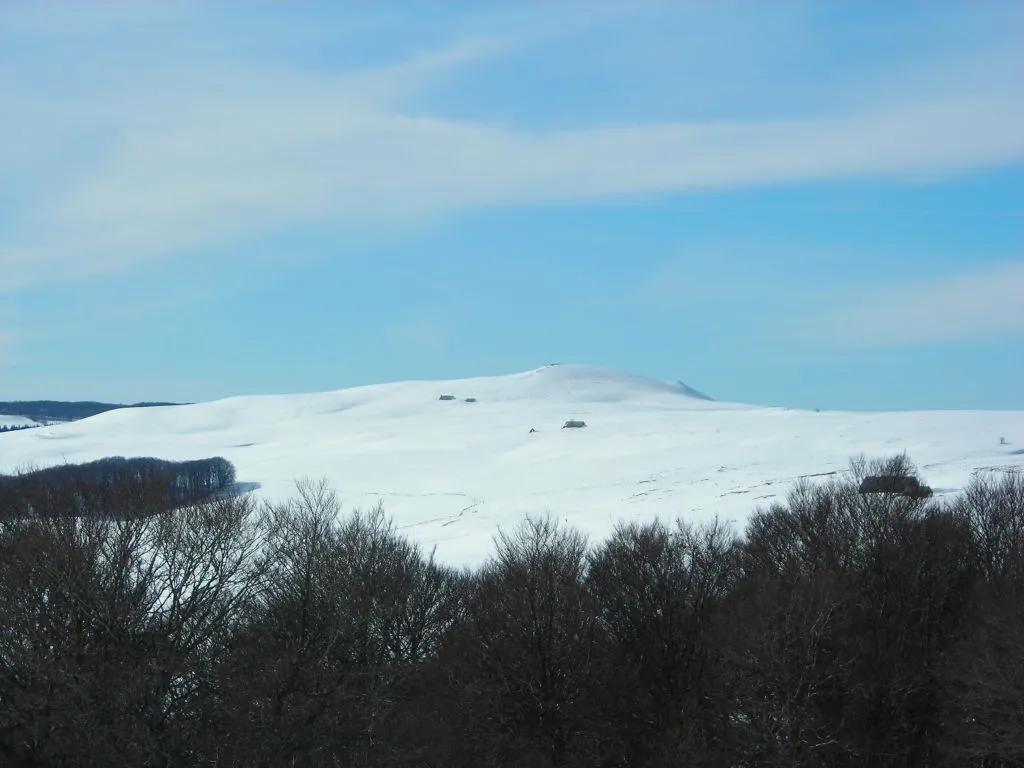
[0,0,1024,409]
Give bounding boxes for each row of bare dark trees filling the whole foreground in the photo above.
[0,459,1024,768]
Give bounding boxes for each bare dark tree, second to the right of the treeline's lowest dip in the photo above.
[588,522,739,765]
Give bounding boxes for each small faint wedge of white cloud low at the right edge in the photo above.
[814,261,1024,346]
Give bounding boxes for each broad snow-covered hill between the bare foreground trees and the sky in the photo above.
[0,366,1024,564]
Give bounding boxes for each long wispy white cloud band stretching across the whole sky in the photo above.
[0,24,1024,291]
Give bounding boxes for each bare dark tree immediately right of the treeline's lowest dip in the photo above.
[450,517,595,766]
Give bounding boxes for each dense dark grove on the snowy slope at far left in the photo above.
[0,457,236,519]
